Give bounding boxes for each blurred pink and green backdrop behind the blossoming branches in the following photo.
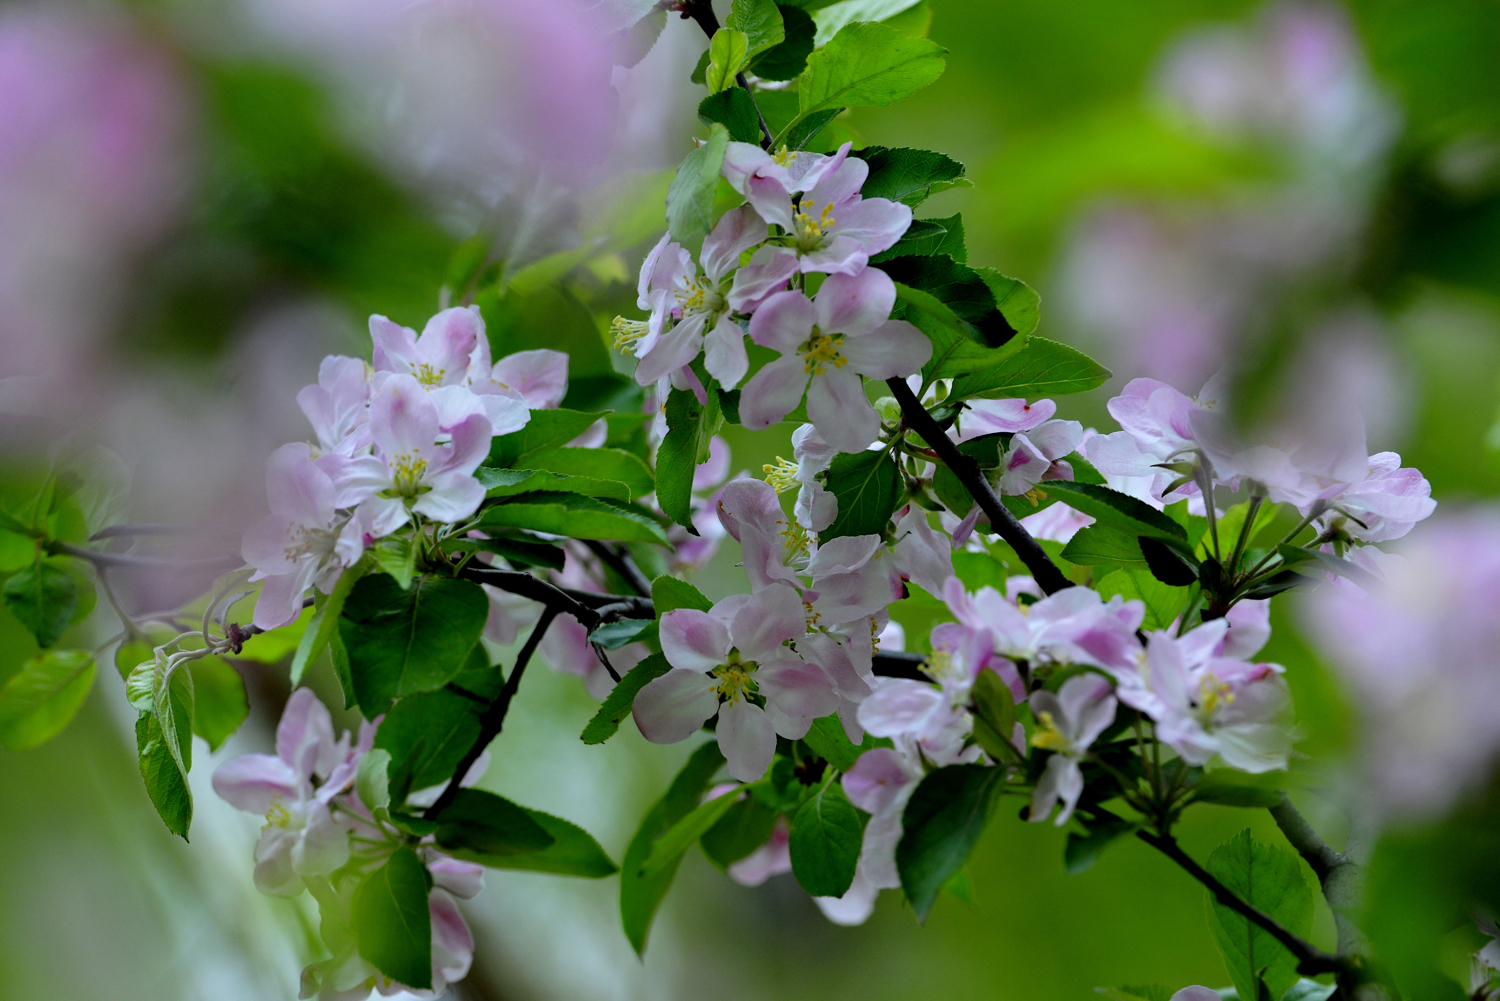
[0,0,1500,1001]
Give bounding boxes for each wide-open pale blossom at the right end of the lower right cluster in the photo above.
[1116,618,1292,773]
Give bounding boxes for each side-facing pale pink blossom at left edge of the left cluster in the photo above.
[240,443,365,629]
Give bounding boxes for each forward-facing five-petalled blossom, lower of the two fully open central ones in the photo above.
[635,584,839,782]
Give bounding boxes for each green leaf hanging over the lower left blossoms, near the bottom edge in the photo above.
[351,846,432,989]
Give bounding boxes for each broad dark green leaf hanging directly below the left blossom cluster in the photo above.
[339,573,489,719]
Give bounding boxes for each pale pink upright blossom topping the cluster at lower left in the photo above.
[213,689,357,896]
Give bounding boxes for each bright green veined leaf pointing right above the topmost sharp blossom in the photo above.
[779,23,947,138]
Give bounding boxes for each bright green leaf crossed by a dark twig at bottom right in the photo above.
[1203,828,1313,998]
